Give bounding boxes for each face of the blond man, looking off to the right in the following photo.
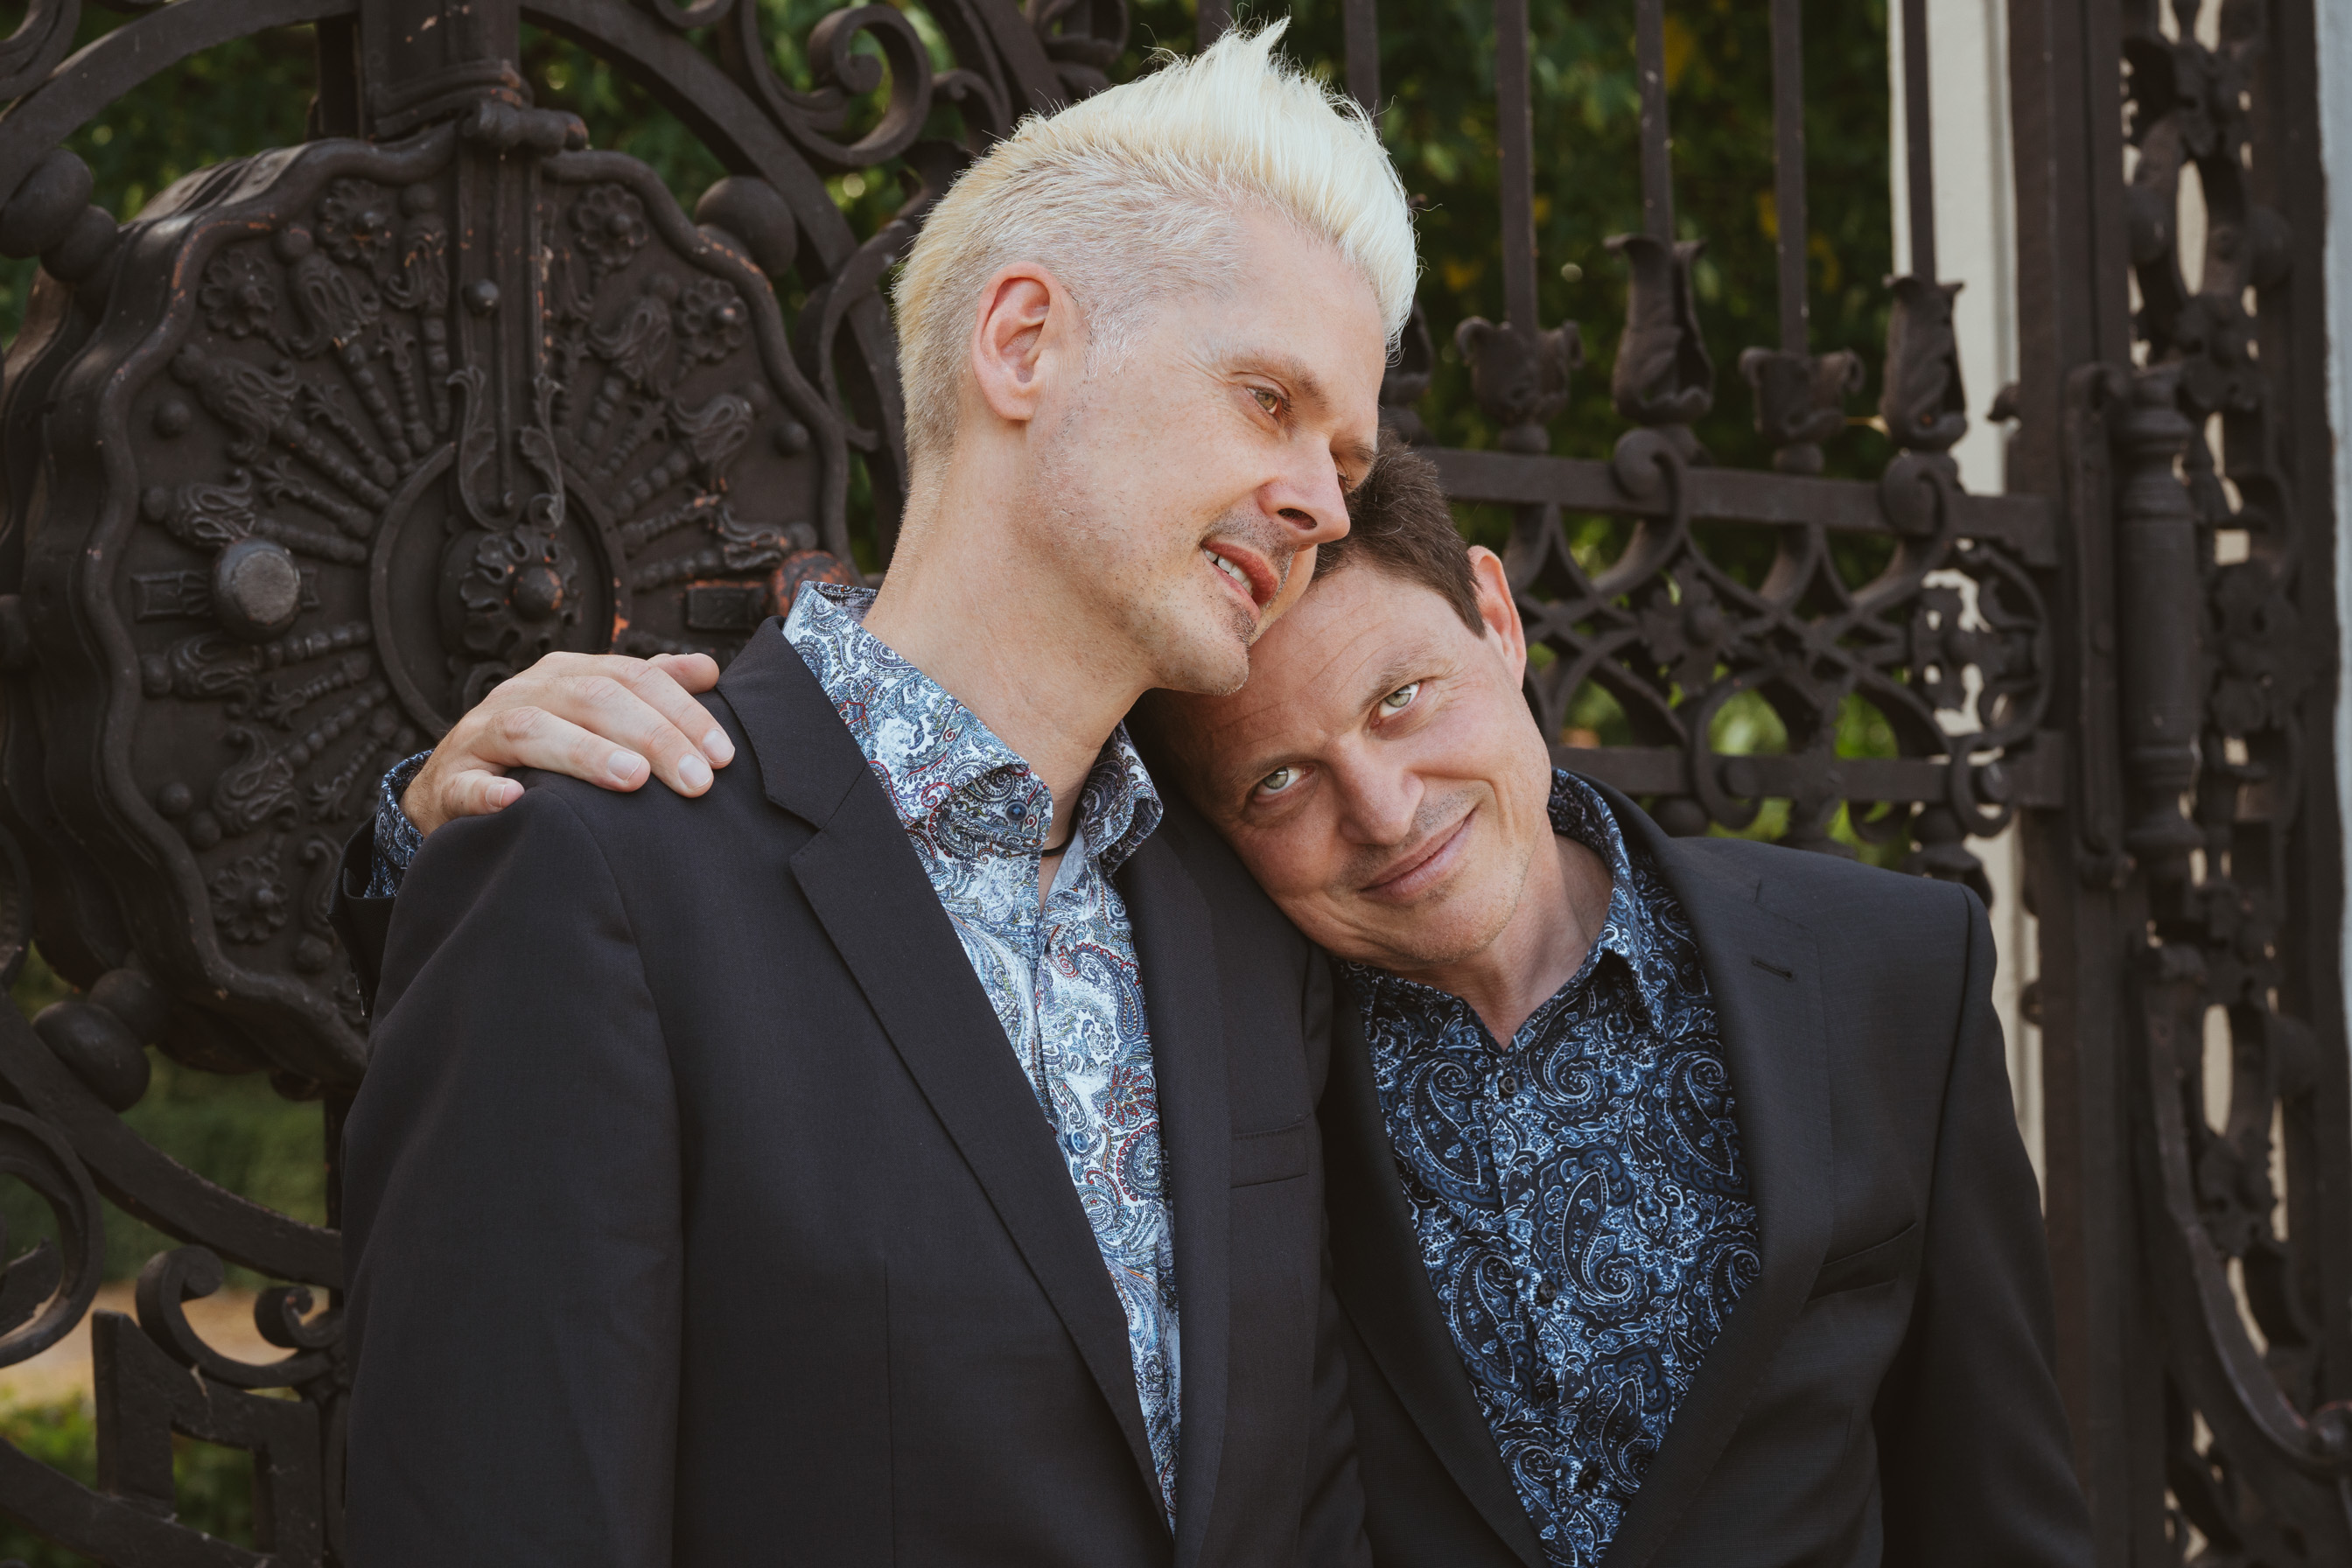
[1032,216,1388,691]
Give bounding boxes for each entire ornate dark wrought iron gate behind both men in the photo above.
[0,0,2323,1568]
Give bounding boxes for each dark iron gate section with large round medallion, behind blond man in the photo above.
[0,0,1127,1565]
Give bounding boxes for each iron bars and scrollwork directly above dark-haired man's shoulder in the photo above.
[1383,0,2058,889]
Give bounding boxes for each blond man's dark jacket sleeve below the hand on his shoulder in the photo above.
[343,788,684,1568]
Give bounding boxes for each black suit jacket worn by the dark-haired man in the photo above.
[1322,788,2091,1568]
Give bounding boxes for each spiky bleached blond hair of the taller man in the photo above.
[893,21,1416,470]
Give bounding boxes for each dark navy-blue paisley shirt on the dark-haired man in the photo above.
[1348,774,1760,1568]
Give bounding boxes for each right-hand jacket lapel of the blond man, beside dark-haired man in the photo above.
[1117,822,1233,1568]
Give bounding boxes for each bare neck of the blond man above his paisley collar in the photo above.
[865,468,1150,842]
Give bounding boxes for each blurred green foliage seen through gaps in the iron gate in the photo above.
[0,0,1894,1568]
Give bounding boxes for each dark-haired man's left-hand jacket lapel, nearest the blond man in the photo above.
[1322,978,1543,1568]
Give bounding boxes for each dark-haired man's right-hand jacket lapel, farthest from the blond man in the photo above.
[1602,788,1835,1568]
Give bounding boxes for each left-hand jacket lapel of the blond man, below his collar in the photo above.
[720,623,1161,1495]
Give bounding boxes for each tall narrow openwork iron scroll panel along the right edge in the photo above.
[2107,4,2352,1564]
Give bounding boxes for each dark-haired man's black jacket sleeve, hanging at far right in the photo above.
[1877,889,2091,1568]
